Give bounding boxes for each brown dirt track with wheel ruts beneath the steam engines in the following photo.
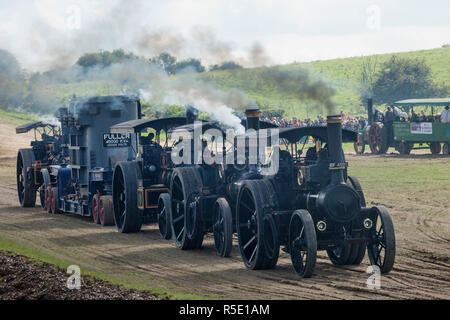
[0,124,450,299]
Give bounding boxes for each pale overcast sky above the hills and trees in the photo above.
[0,0,450,70]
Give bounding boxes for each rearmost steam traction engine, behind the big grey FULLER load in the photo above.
[16,121,67,208]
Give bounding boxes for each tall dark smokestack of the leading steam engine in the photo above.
[327,115,345,184]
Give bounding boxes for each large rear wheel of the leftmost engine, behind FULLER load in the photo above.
[16,149,36,207]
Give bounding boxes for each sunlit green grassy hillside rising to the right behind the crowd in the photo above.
[200,47,450,116]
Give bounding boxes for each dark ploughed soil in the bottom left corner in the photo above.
[0,250,156,300]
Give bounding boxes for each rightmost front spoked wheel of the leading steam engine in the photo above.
[367,206,395,273]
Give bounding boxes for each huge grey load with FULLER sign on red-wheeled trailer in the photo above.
[43,96,141,225]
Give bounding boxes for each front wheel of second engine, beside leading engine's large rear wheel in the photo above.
[213,198,233,257]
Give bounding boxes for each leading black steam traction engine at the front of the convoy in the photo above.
[236,116,395,277]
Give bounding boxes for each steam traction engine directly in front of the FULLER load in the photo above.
[111,107,198,232]
